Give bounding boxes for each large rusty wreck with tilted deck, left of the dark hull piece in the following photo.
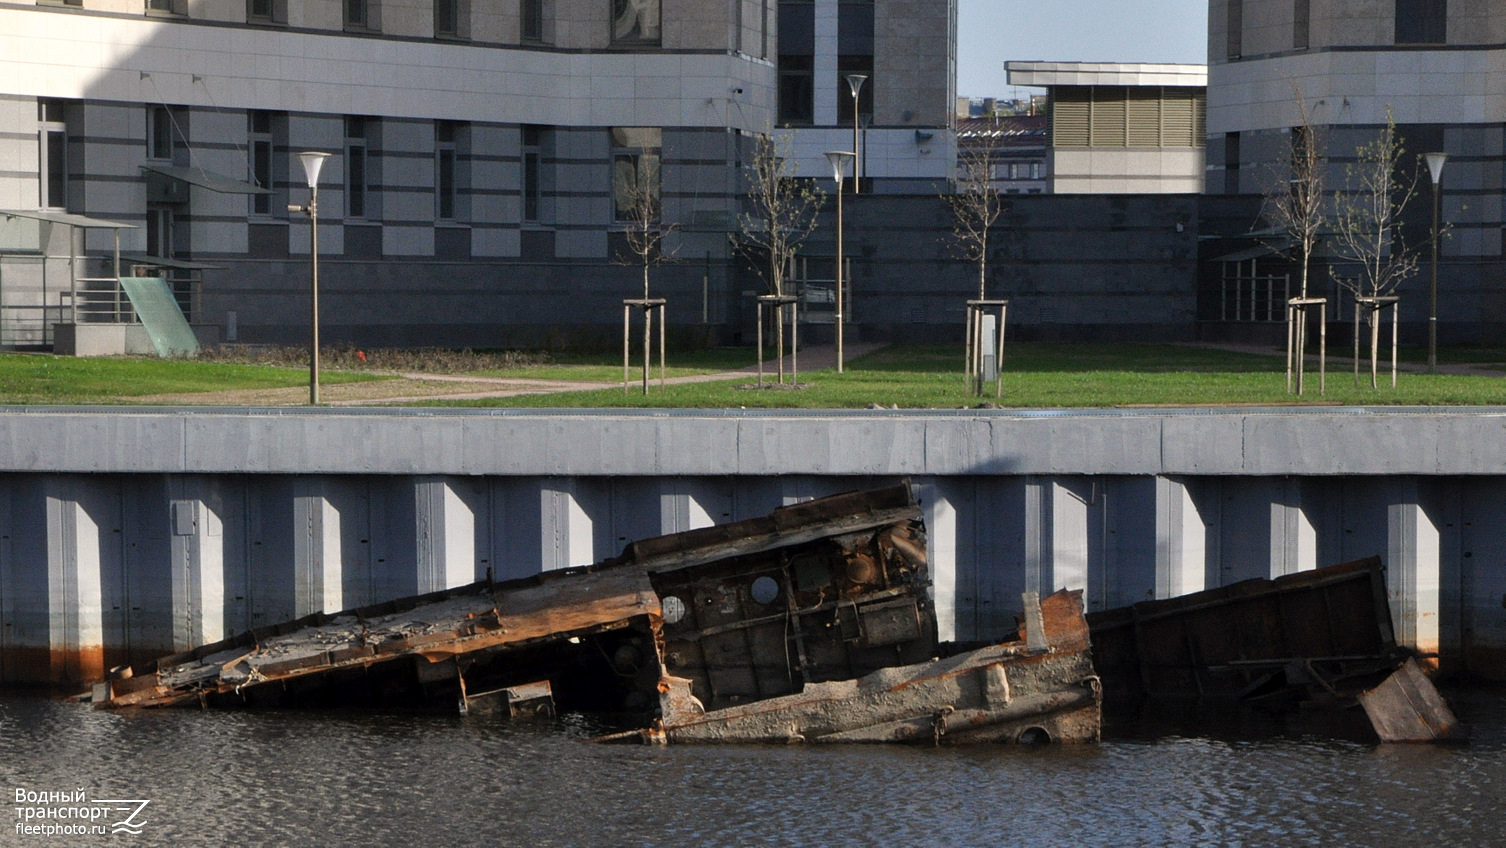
[93,485,1101,743]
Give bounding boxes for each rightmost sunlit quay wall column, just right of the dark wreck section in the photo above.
[1386,479,1441,654]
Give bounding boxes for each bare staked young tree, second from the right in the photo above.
[1261,81,1328,395]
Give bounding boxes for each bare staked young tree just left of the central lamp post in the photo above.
[732,131,827,383]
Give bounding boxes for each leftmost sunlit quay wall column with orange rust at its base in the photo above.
[44,476,104,682]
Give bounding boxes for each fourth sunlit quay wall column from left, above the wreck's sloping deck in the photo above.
[413,477,476,593]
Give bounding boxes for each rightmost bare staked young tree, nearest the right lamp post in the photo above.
[1333,108,1419,389]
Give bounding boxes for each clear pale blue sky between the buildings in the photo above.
[956,0,1208,96]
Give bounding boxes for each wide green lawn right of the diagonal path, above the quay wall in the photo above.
[433,343,1506,408]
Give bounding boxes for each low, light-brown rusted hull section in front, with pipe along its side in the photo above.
[643,592,1101,744]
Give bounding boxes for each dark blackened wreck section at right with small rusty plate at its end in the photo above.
[1087,557,1461,741]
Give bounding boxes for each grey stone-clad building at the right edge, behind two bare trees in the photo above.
[1199,0,1506,343]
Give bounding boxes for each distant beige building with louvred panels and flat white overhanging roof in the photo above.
[1005,62,1208,194]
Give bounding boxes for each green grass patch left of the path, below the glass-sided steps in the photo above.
[0,354,380,404]
